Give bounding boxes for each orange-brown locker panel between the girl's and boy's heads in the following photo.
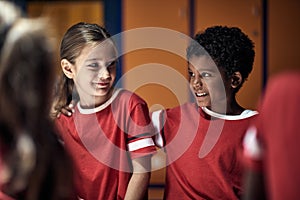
[123,0,189,110]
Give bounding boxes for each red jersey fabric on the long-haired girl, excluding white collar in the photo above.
[57,90,156,200]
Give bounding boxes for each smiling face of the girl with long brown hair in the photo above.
[73,40,117,106]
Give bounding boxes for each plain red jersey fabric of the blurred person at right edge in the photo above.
[247,73,300,200]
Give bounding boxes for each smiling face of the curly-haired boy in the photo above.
[188,55,231,112]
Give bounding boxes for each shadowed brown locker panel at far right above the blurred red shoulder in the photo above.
[268,0,300,77]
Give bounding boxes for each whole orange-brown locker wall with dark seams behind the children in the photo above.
[11,0,300,199]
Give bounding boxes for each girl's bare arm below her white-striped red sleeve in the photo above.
[125,155,151,200]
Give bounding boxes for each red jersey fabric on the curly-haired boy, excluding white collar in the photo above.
[159,103,254,200]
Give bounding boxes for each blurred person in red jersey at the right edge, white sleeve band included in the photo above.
[244,72,300,200]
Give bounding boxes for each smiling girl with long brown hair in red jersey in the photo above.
[55,22,155,200]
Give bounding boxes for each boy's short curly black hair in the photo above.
[187,26,255,82]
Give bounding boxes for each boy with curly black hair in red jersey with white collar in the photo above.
[152,26,257,199]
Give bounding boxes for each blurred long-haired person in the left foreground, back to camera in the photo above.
[0,1,73,200]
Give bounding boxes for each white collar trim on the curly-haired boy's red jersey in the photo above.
[201,107,258,120]
